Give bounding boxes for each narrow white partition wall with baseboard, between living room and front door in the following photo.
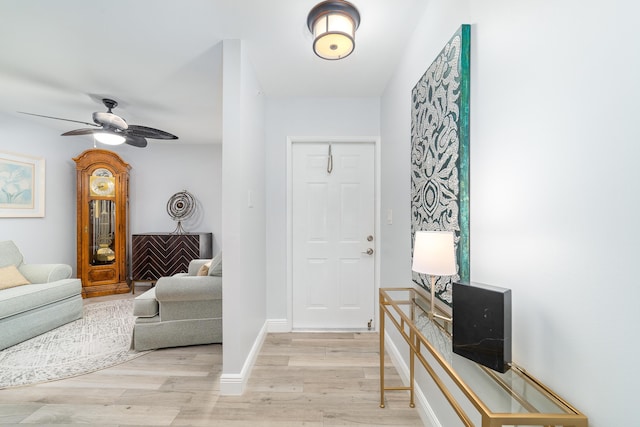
[220,40,266,394]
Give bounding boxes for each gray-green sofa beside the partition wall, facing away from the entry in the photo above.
[132,254,222,351]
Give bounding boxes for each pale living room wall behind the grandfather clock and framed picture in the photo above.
[0,116,222,274]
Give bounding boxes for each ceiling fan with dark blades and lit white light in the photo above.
[20,98,178,148]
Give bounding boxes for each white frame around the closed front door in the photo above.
[286,136,380,331]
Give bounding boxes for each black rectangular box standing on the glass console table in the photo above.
[452,282,511,372]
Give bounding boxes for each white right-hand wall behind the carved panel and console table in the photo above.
[381,0,640,427]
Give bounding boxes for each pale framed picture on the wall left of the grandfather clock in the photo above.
[0,152,45,218]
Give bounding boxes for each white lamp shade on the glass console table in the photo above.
[411,231,456,276]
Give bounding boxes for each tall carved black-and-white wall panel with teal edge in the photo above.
[411,25,471,306]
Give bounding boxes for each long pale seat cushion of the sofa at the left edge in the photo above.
[0,279,82,319]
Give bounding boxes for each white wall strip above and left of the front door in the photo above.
[265,97,380,320]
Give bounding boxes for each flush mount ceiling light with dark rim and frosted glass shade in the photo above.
[307,0,360,60]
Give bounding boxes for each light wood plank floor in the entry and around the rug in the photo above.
[0,299,422,427]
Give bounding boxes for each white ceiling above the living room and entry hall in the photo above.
[0,0,427,144]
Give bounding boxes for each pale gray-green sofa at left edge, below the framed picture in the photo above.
[0,240,83,350]
